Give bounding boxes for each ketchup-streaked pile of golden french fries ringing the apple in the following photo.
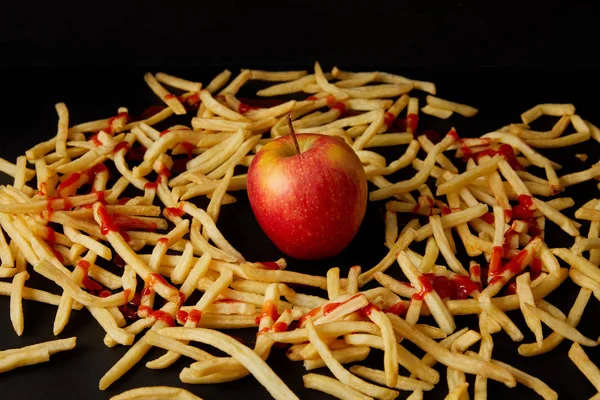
[0,62,600,400]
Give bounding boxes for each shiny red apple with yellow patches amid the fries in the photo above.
[248,134,367,260]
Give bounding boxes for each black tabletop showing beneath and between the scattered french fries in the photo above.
[0,64,600,400]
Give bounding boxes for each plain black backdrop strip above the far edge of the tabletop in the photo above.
[0,0,600,68]
